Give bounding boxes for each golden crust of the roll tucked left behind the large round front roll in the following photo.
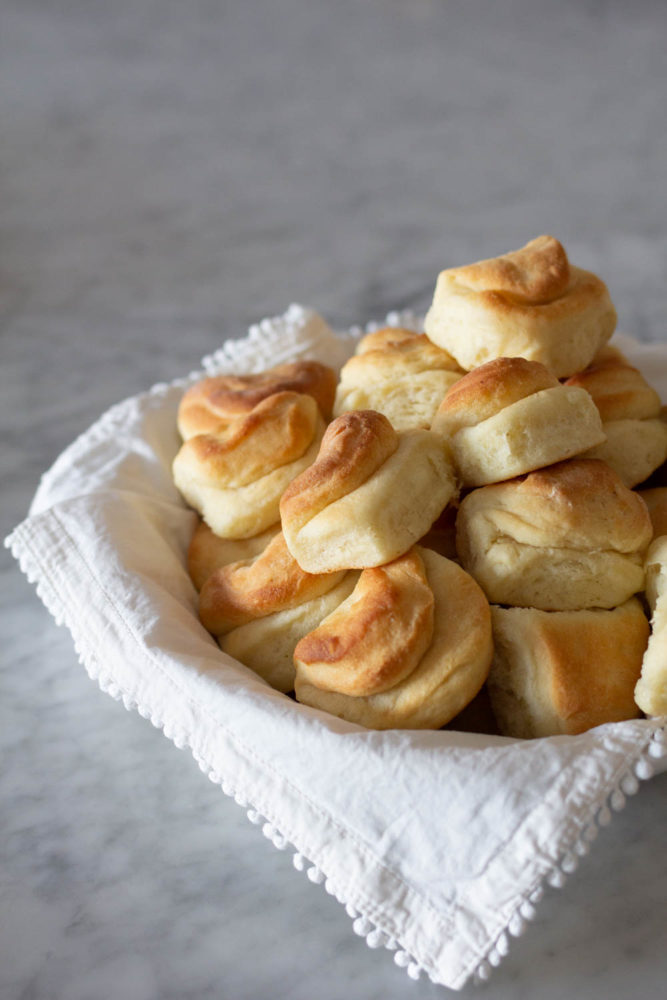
[199,532,343,635]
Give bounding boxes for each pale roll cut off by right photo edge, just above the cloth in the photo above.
[635,535,667,715]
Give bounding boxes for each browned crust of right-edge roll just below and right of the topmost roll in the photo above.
[565,347,660,423]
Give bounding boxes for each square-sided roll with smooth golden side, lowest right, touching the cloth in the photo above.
[487,598,649,739]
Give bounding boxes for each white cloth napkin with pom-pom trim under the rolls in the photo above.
[7,307,667,989]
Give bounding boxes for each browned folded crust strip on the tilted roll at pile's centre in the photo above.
[280,410,398,530]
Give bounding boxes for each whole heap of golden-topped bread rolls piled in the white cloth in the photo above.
[173,236,667,738]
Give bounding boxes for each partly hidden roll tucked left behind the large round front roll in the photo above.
[199,532,358,692]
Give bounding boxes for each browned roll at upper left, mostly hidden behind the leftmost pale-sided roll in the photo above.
[177,361,336,441]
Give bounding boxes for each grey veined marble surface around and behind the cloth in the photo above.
[0,0,667,1000]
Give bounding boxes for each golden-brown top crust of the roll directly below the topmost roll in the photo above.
[433,358,559,434]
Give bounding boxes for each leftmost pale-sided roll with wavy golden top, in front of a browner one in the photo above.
[173,392,324,538]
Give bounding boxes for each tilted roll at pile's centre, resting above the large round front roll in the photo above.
[280,410,456,573]
